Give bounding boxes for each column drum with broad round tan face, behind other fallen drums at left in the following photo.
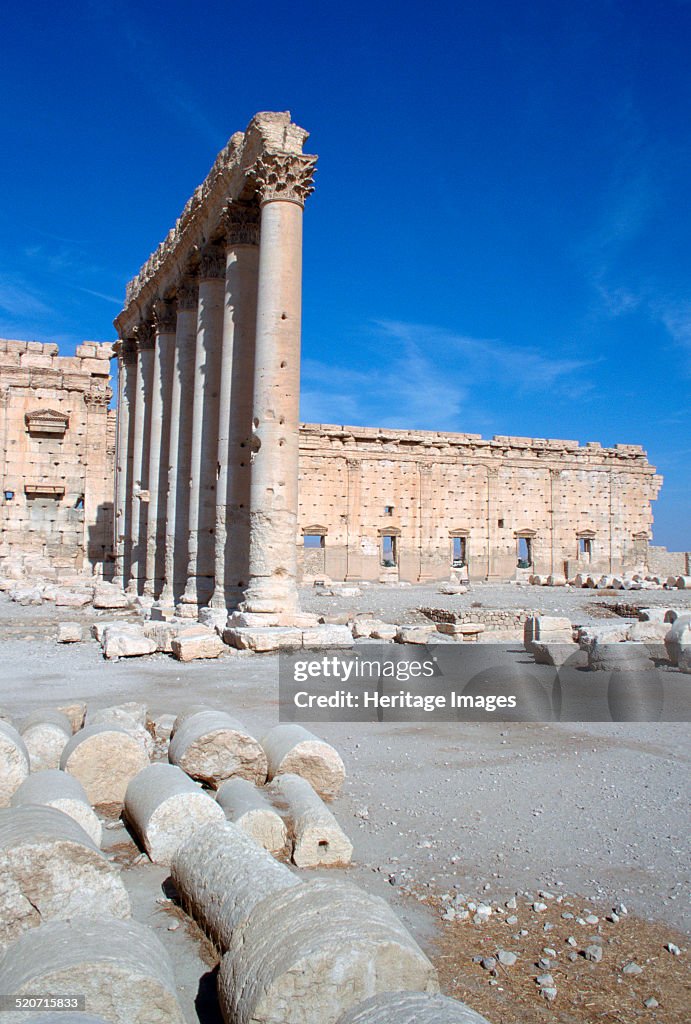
[60,725,148,811]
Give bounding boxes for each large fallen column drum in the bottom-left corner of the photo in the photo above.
[0,912,185,1024]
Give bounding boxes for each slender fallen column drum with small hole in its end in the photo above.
[266,774,353,867]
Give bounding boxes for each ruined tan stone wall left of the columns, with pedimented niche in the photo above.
[0,340,115,574]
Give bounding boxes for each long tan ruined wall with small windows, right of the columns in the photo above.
[298,424,661,582]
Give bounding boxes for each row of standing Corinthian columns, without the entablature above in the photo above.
[115,154,313,621]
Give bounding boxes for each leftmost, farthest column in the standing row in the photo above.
[113,338,136,587]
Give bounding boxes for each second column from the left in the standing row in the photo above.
[127,323,154,594]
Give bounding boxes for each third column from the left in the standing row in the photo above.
[144,299,175,597]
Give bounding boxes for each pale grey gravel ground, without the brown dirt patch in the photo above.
[0,586,691,1024]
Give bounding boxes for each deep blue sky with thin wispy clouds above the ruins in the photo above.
[0,0,691,550]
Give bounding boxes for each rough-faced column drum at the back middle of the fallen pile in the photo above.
[168,711,267,787]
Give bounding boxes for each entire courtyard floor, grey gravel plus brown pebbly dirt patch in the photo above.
[0,585,691,1024]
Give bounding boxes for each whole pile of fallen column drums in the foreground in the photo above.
[0,705,491,1024]
